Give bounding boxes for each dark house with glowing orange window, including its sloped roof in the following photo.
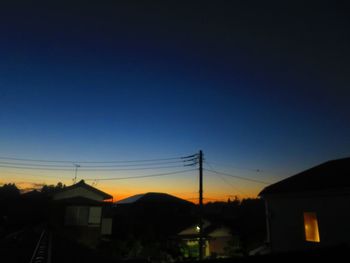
[259,158,350,255]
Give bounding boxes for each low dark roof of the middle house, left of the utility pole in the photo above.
[116,192,193,205]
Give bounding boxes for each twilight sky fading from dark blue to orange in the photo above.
[0,1,350,201]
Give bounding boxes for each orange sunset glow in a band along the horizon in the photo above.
[0,171,262,204]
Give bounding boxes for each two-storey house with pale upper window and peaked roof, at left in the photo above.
[51,180,112,246]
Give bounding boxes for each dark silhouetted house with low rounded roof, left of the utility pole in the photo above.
[113,192,197,242]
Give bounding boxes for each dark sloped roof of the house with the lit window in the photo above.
[259,157,350,196]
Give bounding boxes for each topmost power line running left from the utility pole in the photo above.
[0,155,195,163]
